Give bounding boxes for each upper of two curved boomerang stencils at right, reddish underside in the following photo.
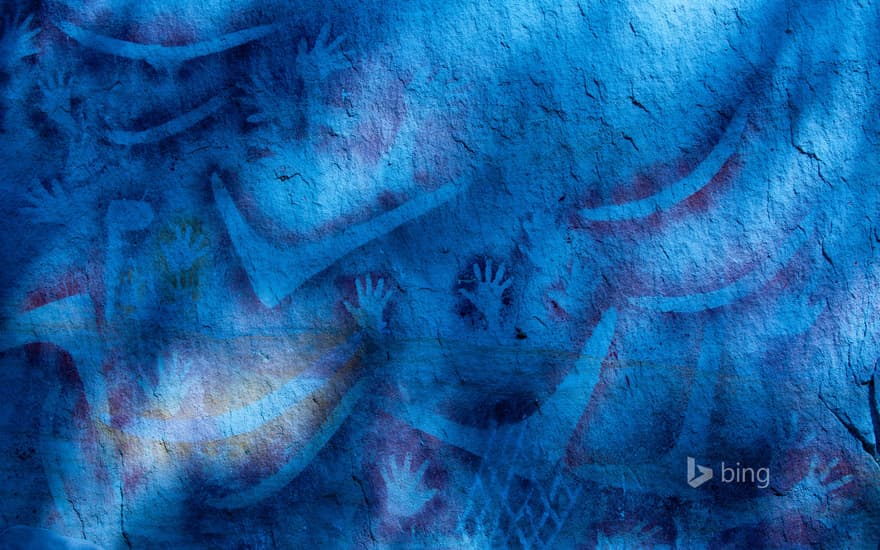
[578,96,752,222]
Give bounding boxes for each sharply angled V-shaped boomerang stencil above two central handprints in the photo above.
[211,173,467,308]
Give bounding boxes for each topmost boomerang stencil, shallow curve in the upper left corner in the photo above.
[58,21,279,66]
